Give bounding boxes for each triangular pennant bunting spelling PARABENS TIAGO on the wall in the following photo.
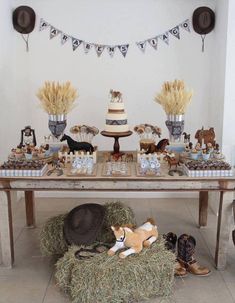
[39,18,190,58]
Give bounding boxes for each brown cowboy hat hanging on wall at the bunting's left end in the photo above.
[12,6,36,34]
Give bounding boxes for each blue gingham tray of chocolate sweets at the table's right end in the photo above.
[183,160,233,177]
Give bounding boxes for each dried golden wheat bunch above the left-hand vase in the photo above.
[37,81,78,115]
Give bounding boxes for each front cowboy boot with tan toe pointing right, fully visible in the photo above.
[177,234,210,276]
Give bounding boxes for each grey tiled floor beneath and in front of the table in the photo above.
[0,198,235,303]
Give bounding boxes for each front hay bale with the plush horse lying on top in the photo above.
[56,238,175,303]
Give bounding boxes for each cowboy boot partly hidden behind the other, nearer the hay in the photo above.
[163,232,187,277]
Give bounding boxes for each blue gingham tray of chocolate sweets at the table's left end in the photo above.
[0,160,48,177]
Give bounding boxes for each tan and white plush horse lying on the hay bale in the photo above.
[108,218,158,259]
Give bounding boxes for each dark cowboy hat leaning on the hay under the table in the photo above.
[64,203,105,245]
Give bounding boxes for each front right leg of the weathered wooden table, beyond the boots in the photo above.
[215,192,233,270]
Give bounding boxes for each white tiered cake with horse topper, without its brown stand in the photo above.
[105,90,129,133]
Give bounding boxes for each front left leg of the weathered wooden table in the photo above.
[0,191,14,267]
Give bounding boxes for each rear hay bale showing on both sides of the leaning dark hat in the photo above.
[40,201,135,256]
